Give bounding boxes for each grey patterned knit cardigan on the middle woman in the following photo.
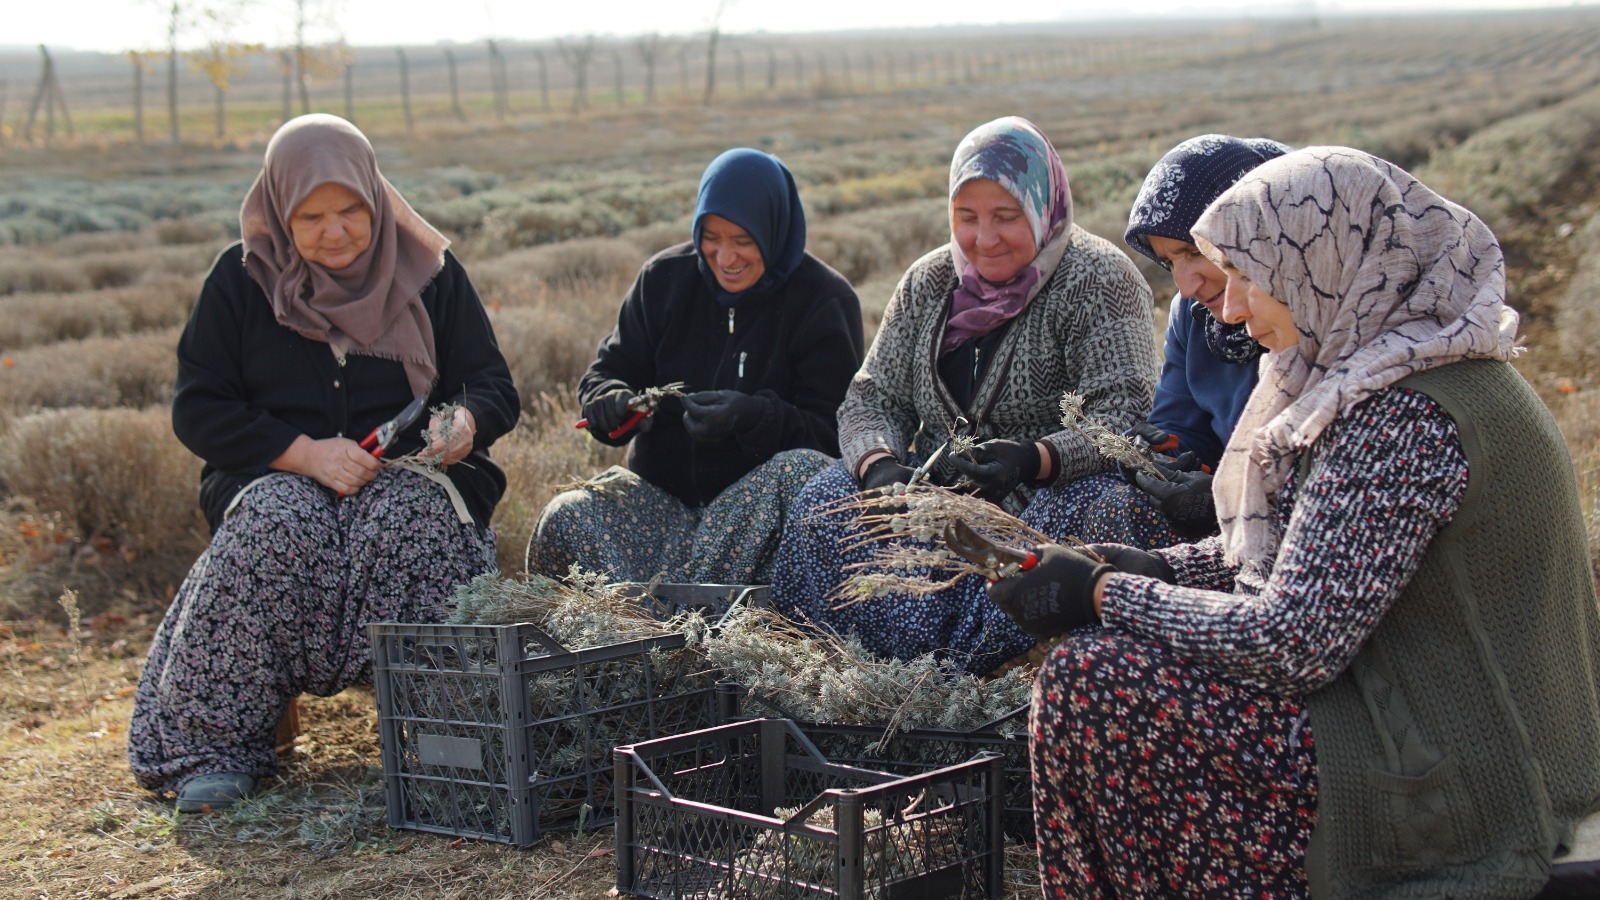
[838,226,1158,496]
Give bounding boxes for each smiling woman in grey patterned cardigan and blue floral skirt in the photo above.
[773,117,1157,673]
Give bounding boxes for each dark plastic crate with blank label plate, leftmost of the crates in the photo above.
[368,623,718,847]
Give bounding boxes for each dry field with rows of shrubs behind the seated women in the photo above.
[0,10,1600,898]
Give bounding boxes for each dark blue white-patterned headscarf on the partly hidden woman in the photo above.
[1123,135,1290,364]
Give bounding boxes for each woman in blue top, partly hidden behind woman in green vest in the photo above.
[1040,135,1290,549]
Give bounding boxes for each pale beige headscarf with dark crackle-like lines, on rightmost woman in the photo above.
[1194,147,1517,564]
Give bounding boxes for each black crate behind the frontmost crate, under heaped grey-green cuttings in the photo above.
[717,682,1034,844]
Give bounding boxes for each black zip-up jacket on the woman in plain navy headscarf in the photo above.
[578,242,862,508]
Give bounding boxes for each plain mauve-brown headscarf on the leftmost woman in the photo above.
[238,114,450,396]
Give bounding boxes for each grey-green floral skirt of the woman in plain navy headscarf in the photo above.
[526,450,832,585]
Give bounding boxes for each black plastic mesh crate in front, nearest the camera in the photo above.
[629,723,997,900]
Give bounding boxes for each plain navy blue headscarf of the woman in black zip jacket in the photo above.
[694,147,805,307]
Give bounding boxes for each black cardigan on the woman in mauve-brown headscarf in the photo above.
[173,243,522,532]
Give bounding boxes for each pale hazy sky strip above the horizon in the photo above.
[9,0,1587,51]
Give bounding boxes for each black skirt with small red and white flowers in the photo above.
[1032,628,1317,900]
